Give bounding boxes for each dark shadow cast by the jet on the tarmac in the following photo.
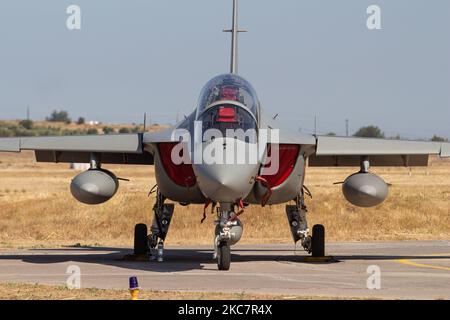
[0,247,450,273]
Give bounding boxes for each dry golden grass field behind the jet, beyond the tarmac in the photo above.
[0,152,450,247]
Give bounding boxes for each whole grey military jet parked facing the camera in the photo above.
[0,0,450,270]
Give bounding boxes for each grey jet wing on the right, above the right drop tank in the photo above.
[309,136,450,167]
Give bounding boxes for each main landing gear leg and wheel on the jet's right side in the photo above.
[286,191,325,258]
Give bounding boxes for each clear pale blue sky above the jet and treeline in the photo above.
[0,0,450,138]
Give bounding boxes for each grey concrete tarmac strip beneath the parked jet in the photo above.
[0,241,450,299]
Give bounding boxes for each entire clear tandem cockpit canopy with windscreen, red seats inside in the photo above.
[196,74,259,134]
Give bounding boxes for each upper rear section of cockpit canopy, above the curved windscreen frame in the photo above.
[197,74,259,119]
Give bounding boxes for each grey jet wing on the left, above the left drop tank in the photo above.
[0,133,153,164]
